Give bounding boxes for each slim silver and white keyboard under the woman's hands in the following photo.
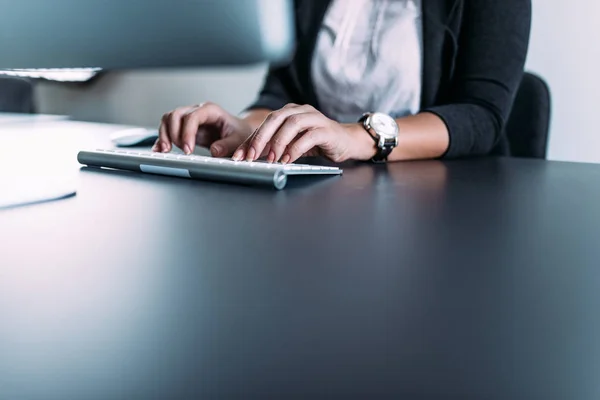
[77,149,343,189]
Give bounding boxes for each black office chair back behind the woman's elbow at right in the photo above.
[506,73,552,160]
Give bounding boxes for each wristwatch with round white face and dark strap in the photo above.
[358,112,398,163]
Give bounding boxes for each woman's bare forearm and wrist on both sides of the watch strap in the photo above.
[346,113,450,162]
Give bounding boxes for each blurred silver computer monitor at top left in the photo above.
[0,0,294,69]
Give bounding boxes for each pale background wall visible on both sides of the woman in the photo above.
[39,0,600,162]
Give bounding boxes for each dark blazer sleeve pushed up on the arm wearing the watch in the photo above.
[423,0,531,158]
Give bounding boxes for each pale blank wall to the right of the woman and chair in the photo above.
[528,0,600,162]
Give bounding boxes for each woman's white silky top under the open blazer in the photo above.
[312,0,423,123]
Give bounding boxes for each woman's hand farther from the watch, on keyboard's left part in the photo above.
[152,103,254,157]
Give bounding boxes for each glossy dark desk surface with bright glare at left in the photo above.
[0,123,600,400]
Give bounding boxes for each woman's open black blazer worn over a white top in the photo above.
[249,0,531,158]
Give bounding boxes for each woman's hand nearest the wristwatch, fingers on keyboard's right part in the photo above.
[233,104,375,164]
